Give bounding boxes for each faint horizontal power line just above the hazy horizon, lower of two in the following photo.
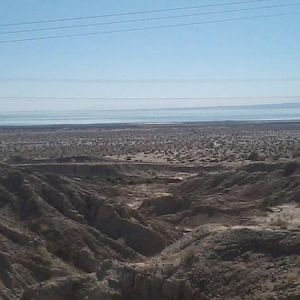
[0,95,300,101]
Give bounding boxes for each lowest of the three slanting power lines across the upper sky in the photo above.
[0,12,300,44]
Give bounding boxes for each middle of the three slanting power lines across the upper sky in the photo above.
[0,3,300,35]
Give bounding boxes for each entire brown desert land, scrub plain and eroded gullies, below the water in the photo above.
[0,122,300,300]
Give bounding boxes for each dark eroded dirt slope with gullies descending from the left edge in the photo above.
[0,165,179,299]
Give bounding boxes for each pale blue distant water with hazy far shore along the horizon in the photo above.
[0,103,300,126]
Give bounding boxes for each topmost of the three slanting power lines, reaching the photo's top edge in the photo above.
[0,0,284,27]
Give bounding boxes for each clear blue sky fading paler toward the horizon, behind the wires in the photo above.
[0,0,300,112]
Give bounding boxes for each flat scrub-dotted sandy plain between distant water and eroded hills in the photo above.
[0,123,300,165]
